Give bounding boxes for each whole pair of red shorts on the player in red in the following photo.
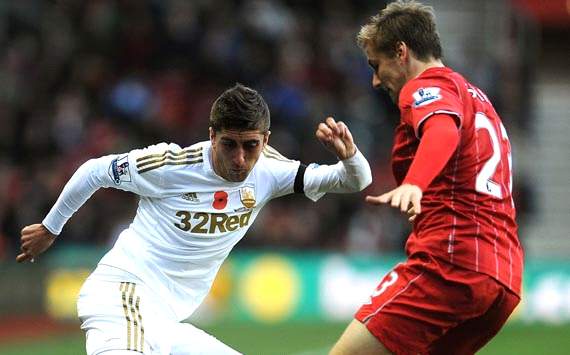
[355,254,520,354]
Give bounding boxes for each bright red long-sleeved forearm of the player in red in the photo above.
[402,115,459,191]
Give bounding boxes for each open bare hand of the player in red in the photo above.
[366,184,423,222]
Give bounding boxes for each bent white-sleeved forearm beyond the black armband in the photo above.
[305,150,372,197]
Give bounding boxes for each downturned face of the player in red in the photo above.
[366,46,406,104]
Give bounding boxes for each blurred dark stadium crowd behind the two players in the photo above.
[0,0,528,260]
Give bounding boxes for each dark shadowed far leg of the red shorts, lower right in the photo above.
[430,277,520,354]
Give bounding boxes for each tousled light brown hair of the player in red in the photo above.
[356,0,443,61]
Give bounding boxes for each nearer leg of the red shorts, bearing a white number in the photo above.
[348,254,486,353]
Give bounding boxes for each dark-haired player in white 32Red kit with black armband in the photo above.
[17,84,372,355]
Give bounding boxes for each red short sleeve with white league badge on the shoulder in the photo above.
[399,77,463,138]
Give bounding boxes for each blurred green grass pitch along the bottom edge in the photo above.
[0,323,570,355]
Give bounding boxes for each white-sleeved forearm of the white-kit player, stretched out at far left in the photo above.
[42,157,110,235]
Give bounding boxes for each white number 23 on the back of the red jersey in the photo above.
[475,112,513,199]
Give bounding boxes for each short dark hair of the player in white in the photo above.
[210,83,270,133]
